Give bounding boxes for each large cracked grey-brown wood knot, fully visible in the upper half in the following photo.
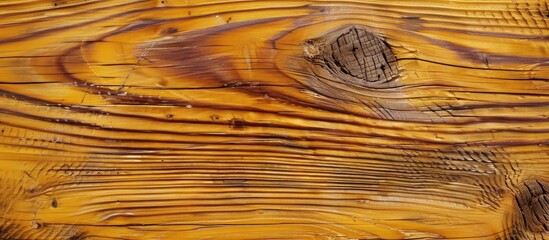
[303,26,398,87]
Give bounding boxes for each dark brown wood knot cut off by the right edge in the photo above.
[513,180,549,237]
